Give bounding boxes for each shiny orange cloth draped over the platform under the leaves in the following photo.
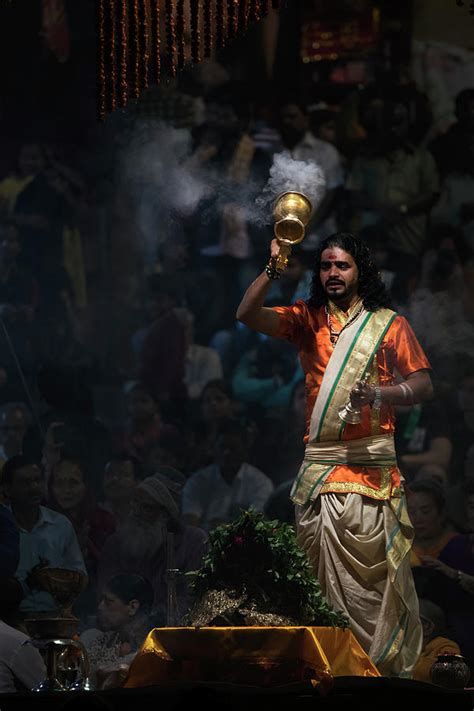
[124,627,380,688]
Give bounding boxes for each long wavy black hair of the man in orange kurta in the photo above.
[308,232,390,311]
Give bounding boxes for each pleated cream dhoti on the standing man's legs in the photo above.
[296,493,422,677]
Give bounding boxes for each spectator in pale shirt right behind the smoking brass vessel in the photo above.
[280,101,344,250]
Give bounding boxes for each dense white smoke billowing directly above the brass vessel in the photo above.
[251,153,326,224]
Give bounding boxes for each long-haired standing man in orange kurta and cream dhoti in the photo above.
[237,233,432,676]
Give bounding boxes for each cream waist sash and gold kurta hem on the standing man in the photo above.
[290,435,397,505]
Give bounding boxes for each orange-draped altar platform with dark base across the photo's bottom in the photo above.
[0,627,474,711]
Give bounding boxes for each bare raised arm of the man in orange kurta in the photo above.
[236,239,280,336]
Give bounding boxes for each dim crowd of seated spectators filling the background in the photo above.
[0,61,474,691]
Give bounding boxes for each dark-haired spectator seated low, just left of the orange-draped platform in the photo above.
[80,575,155,689]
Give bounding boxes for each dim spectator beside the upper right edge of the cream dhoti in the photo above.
[407,479,458,566]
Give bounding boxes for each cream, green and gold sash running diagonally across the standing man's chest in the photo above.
[309,309,396,442]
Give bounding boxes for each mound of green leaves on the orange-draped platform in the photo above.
[188,510,348,627]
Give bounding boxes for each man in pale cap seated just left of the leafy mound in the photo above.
[98,467,206,623]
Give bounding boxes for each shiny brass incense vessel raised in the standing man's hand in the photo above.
[273,191,313,272]
